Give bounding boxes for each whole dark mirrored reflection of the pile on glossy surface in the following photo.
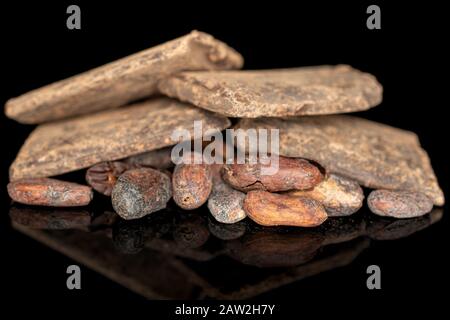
[10,205,442,299]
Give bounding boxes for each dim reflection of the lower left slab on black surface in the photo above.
[13,223,201,299]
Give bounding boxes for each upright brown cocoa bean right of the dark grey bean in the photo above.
[172,163,213,210]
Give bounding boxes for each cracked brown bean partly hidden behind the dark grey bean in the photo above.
[86,161,129,196]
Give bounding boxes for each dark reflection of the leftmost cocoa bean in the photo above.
[9,205,91,230]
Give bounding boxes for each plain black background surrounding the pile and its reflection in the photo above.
[0,1,450,316]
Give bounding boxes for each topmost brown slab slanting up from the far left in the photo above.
[5,31,243,123]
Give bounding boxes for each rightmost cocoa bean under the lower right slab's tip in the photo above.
[367,190,433,218]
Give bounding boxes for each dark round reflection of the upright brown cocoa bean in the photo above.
[173,213,209,249]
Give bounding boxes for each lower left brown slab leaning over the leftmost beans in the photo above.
[10,98,230,180]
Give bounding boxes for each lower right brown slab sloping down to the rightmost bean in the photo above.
[237,115,444,205]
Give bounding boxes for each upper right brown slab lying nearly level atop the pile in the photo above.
[158,65,382,118]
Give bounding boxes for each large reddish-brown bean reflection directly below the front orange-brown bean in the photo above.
[225,231,323,268]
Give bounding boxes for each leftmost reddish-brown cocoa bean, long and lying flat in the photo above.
[8,178,93,207]
